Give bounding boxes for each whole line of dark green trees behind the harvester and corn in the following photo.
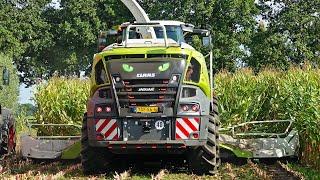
[0,0,320,85]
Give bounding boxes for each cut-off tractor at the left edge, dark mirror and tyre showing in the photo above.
[0,66,16,157]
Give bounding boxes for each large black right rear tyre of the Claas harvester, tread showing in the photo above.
[188,98,220,175]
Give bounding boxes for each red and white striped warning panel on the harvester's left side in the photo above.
[96,119,120,140]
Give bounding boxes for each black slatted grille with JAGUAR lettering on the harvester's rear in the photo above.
[115,79,178,109]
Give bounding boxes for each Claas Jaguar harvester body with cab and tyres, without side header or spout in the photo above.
[81,1,220,176]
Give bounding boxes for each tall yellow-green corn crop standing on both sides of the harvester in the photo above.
[35,65,320,170]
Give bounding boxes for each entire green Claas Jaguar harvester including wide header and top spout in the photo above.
[20,0,299,174]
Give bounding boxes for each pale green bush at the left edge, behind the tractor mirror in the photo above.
[0,53,19,110]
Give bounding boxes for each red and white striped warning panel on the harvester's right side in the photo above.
[176,118,200,140]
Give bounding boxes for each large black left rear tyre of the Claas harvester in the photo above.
[80,114,111,175]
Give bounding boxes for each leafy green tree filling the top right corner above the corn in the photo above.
[271,0,320,64]
